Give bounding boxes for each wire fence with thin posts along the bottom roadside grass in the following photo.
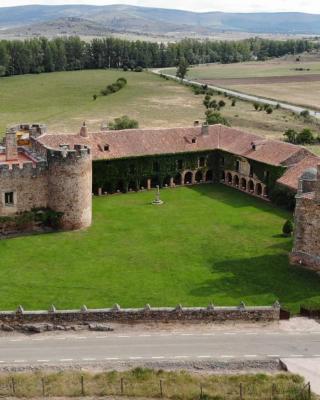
[0,373,313,400]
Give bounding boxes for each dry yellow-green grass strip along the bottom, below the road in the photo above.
[0,367,306,400]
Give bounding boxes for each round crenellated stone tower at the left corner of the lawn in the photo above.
[47,145,92,230]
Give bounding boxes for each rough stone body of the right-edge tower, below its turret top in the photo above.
[290,194,320,271]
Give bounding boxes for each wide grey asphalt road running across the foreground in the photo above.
[0,331,320,365]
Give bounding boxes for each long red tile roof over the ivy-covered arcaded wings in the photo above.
[37,125,320,188]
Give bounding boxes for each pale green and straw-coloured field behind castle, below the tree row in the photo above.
[0,70,203,132]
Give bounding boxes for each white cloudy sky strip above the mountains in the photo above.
[0,0,320,14]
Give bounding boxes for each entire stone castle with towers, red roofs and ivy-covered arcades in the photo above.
[0,124,320,270]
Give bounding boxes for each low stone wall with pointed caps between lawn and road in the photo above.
[0,303,280,325]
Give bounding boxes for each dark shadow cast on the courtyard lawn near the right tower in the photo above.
[190,254,320,304]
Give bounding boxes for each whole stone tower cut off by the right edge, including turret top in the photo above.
[290,166,320,271]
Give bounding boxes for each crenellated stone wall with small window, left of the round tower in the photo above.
[0,162,48,216]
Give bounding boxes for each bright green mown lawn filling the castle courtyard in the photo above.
[0,185,320,311]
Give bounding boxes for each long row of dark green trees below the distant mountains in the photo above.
[0,37,318,75]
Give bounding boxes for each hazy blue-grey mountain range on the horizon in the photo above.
[0,5,320,36]
